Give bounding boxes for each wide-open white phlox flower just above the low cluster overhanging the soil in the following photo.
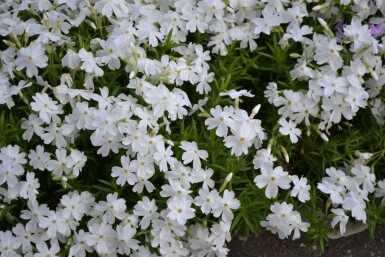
[254,163,291,199]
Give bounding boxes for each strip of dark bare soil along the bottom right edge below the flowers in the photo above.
[228,225,385,257]
